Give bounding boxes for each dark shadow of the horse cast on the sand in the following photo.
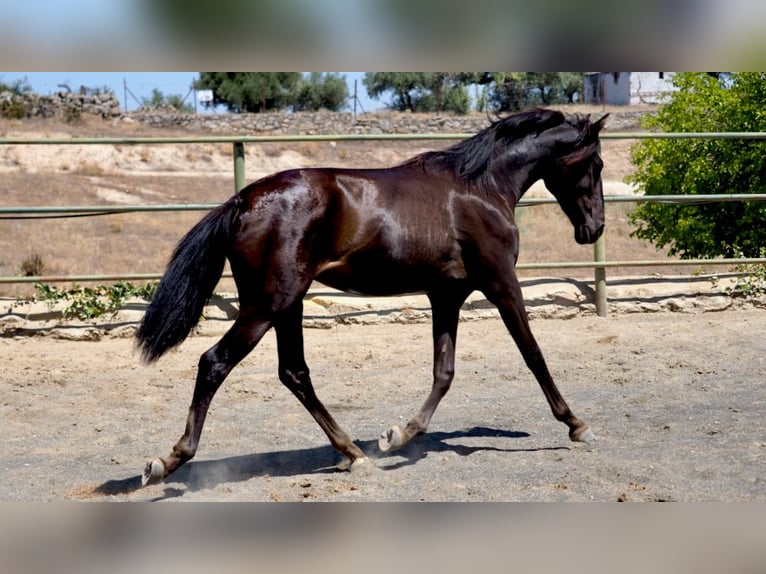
[93,427,566,500]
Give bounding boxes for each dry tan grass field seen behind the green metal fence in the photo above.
[0,113,712,302]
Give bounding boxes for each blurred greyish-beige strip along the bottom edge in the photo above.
[0,504,766,574]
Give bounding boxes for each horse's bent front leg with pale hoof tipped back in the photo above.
[378,293,468,452]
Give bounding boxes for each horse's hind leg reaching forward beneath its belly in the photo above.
[274,299,368,470]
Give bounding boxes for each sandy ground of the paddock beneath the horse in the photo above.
[0,298,766,501]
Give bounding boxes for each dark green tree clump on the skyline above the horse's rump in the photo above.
[198,72,348,112]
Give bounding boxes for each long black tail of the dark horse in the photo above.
[136,196,241,362]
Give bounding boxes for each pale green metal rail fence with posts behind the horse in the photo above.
[0,132,766,316]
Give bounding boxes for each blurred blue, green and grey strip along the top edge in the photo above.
[0,0,766,71]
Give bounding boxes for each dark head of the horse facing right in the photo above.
[543,114,609,244]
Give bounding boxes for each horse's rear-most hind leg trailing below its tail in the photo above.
[142,312,271,485]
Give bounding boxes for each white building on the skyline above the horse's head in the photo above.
[585,72,675,106]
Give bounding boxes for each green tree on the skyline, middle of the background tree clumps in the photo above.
[362,72,473,114]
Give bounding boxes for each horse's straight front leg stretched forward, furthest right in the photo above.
[484,273,596,443]
